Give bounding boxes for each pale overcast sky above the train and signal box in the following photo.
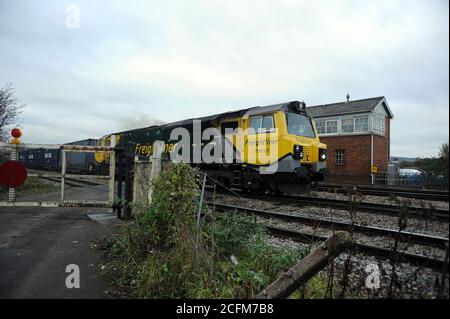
[0,0,449,156]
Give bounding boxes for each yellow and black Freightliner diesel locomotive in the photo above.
[95,101,327,193]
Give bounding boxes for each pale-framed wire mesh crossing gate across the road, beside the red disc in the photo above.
[0,144,115,206]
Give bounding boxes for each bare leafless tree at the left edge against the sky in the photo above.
[0,83,25,140]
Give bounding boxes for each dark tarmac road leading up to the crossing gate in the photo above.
[0,207,120,298]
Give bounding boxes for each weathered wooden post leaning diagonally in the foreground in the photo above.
[256,231,352,299]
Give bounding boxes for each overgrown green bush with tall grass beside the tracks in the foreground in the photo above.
[104,164,305,298]
